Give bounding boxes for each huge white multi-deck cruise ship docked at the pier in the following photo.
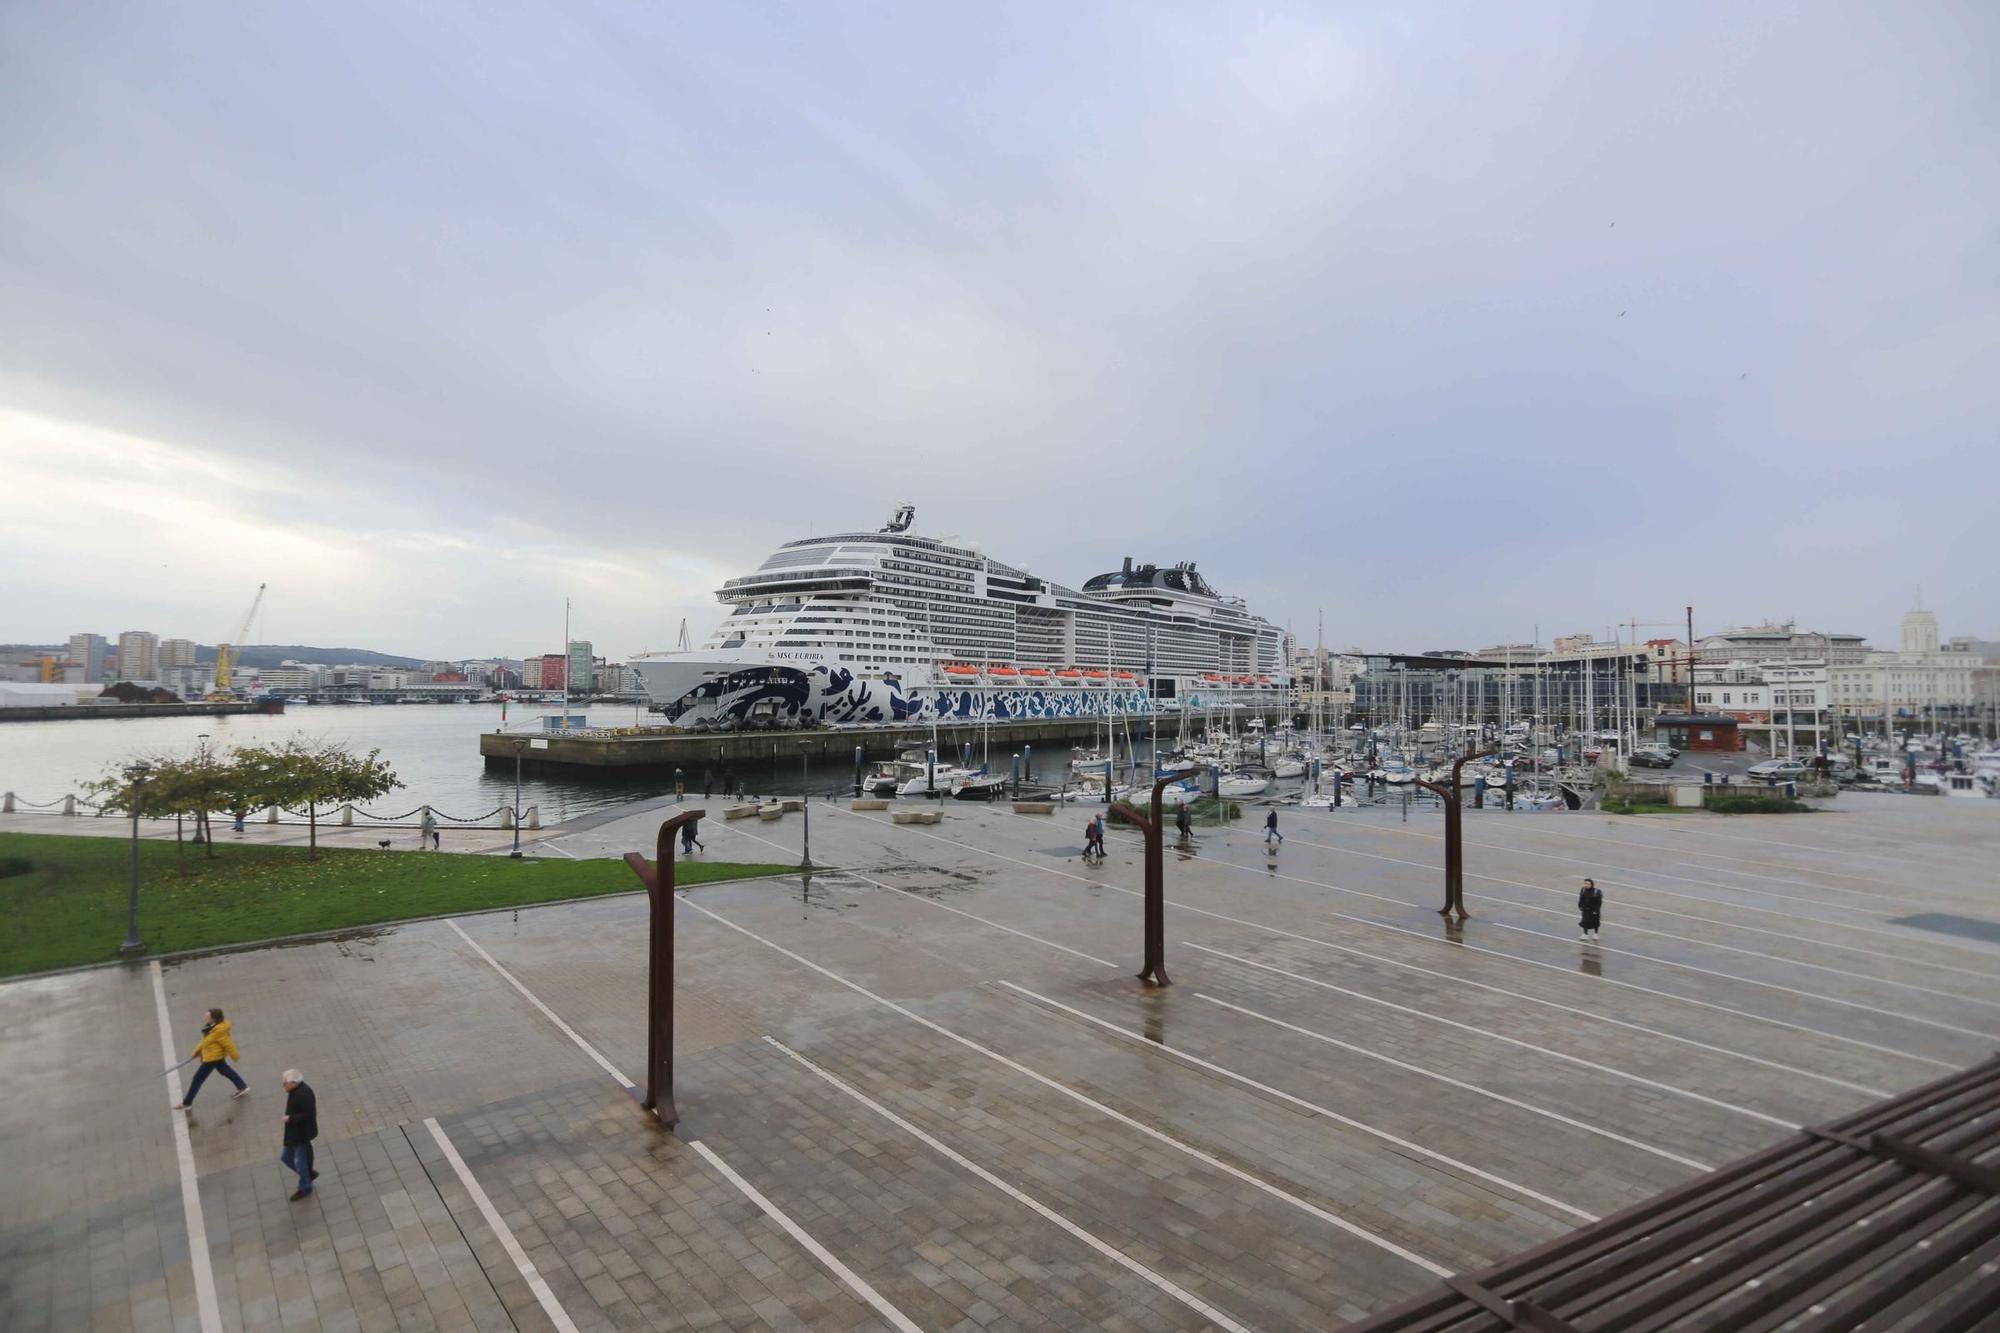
[632,504,1288,727]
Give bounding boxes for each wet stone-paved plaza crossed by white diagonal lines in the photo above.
[0,797,2000,1331]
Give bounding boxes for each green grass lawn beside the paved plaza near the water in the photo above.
[0,833,792,977]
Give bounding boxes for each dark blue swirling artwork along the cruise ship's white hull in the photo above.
[660,664,1154,727]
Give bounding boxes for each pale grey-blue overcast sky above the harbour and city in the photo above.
[0,0,2000,658]
